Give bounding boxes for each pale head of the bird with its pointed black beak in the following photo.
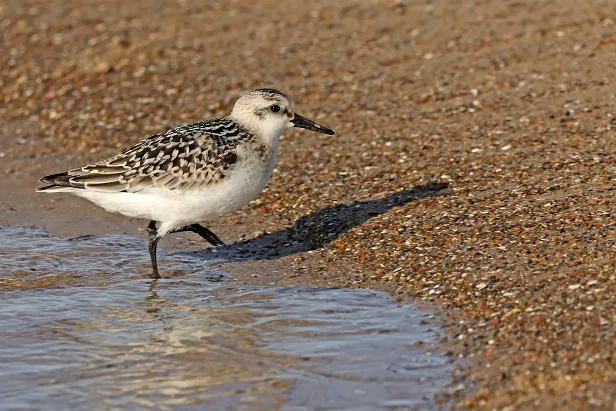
[229,88,334,139]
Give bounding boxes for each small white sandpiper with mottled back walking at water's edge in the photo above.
[36,88,335,279]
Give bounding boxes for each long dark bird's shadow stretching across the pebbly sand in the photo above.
[175,182,449,263]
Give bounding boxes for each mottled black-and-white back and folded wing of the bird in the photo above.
[39,118,254,192]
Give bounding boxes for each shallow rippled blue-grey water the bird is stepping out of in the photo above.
[0,227,450,410]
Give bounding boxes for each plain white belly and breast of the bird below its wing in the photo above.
[73,147,277,235]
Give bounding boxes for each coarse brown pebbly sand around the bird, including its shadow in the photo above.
[0,0,616,409]
